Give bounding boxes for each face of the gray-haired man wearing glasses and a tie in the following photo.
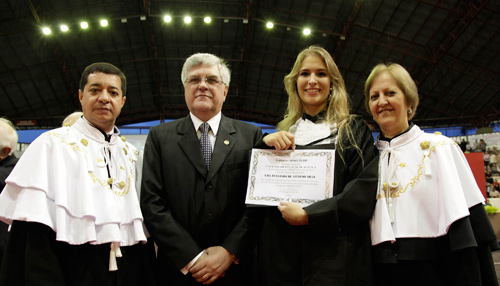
[184,64,228,122]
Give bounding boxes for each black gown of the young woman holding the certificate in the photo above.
[248,116,378,286]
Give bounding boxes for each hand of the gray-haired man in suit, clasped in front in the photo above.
[189,246,235,284]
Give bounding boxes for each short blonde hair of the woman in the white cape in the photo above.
[365,63,418,120]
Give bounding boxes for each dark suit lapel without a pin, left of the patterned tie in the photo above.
[177,115,207,177]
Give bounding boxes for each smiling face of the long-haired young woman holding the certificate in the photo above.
[297,55,331,116]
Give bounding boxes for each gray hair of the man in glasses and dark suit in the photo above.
[181,53,231,86]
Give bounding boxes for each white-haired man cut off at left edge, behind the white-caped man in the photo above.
[0,118,18,268]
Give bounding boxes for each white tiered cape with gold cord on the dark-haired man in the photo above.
[0,118,147,270]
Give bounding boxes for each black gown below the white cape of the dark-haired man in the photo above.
[0,221,155,286]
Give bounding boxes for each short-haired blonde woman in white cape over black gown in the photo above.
[365,64,499,286]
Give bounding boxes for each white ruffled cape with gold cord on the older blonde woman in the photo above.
[371,125,484,245]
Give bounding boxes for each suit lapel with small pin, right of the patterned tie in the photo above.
[207,115,236,181]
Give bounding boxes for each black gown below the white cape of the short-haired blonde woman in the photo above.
[373,204,500,286]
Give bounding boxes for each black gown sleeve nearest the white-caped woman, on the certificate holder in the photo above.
[305,116,378,231]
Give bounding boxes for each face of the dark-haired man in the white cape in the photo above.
[78,72,126,132]
